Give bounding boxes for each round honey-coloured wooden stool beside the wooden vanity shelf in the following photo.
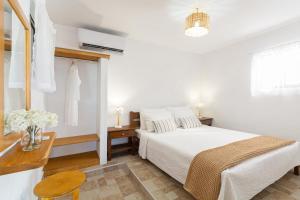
[34,170,86,200]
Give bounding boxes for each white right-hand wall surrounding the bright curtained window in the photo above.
[199,19,300,141]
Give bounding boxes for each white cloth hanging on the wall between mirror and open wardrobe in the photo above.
[32,0,56,92]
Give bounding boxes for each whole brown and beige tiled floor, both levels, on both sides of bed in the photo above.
[60,155,300,200]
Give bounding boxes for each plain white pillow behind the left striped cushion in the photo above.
[140,108,172,132]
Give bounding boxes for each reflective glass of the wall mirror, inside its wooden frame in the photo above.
[4,1,25,111]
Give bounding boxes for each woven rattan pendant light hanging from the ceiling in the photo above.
[185,8,209,37]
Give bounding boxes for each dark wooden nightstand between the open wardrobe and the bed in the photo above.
[107,126,137,160]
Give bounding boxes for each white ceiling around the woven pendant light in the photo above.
[47,0,300,53]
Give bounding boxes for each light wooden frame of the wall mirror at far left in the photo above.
[0,0,31,135]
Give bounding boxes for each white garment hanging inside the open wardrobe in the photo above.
[65,63,81,126]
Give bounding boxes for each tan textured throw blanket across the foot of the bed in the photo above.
[184,136,295,200]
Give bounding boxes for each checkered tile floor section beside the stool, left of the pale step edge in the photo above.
[58,164,152,200]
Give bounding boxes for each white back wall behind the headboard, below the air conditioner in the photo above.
[108,36,201,125]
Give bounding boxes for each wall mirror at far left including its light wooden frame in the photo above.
[2,0,31,135]
